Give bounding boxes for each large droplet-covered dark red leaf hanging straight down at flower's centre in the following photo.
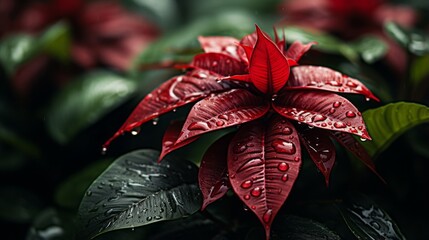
[228,116,301,240]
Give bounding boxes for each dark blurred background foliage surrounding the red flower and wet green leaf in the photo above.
[0,0,429,239]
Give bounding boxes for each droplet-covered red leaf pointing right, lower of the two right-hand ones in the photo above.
[272,90,371,139]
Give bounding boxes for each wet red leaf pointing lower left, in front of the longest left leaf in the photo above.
[176,89,270,144]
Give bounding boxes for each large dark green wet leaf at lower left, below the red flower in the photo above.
[79,150,201,237]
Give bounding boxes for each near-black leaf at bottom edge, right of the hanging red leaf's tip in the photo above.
[272,215,341,240]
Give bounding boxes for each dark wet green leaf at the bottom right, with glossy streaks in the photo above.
[339,195,405,240]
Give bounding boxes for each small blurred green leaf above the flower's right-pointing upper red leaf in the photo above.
[352,35,387,63]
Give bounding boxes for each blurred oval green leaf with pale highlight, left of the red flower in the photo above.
[46,71,136,144]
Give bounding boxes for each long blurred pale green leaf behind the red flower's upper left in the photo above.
[134,12,255,70]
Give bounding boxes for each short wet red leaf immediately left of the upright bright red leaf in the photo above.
[190,53,247,76]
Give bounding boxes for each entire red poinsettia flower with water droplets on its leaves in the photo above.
[105,27,377,239]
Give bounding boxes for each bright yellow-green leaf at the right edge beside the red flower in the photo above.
[362,102,429,157]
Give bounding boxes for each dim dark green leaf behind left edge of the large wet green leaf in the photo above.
[55,160,112,209]
